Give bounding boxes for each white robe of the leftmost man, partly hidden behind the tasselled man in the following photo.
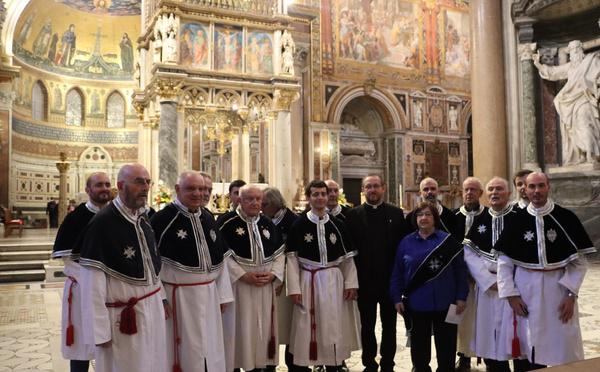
[60,257,94,360]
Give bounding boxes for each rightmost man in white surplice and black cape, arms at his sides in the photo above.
[495,172,596,368]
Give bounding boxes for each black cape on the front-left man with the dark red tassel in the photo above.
[74,199,161,285]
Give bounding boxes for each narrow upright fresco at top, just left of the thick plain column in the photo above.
[444,10,471,77]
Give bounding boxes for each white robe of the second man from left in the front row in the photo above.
[160,263,233,372]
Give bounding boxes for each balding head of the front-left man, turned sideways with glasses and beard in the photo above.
[117,164,152,210]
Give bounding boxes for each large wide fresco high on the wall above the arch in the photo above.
[333,0,421,68]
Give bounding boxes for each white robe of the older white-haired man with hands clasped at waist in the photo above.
[223,254,285,371]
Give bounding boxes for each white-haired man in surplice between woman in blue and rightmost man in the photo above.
[464,177,516,372]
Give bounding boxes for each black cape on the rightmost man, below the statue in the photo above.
[495,202,596,269]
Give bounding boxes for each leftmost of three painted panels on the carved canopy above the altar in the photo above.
[179,23,210,68]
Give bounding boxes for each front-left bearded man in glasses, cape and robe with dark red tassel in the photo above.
[76,164,168,372]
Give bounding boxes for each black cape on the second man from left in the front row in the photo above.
[150,203,230,274]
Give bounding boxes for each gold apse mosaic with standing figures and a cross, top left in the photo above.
[13,0,140,80]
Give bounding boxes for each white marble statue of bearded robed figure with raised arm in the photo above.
[532,40,600,165]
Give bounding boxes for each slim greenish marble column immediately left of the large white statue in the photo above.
[518,43,540,169]
